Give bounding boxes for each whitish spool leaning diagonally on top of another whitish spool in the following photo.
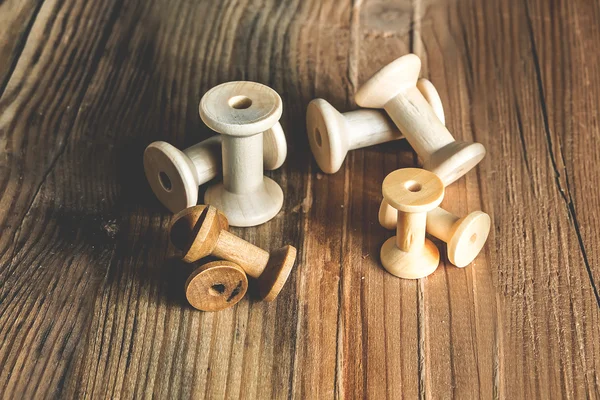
[355,54,485,185]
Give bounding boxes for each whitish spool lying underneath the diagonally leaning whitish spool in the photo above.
[306,79,444,174]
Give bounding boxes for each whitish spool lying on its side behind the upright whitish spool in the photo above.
[144,123,287,213]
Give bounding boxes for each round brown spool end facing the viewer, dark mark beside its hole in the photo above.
[185,261,248,311]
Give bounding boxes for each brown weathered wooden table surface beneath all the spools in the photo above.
[0,0,600,399]
